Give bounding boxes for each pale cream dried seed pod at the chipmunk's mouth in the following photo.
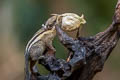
[60,13,86,31]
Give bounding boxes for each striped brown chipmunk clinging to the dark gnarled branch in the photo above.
[24,16,57,80]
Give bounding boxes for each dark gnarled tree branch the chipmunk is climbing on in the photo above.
[31,0,120,80]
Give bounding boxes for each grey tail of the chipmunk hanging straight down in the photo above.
[25,52,30,80]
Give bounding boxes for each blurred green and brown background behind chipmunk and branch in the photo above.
[0,0,120,80]
